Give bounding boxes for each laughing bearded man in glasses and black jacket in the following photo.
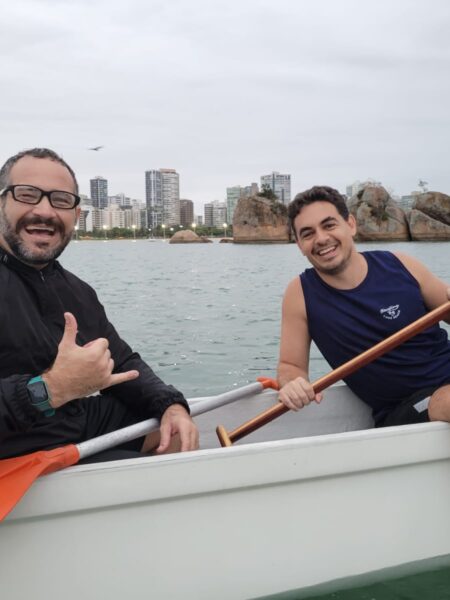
[0,148,198,458]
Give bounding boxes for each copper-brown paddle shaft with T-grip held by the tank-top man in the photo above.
[216,301,450,446]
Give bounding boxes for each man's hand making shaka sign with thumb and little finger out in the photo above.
[42,313,139,408]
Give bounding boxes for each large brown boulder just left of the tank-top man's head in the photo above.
[233,196,290,244]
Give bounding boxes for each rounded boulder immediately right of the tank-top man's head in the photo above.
[347,186,410,241]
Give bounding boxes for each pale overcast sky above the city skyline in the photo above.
[0,0,450,213]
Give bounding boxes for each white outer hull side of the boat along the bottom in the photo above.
[0,390,450,600]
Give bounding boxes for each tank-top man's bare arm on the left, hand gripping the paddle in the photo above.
[278,277,321,410]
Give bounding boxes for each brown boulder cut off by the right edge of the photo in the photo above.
[408,192,450,241]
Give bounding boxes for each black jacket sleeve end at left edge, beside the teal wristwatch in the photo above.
[0,375,41,443]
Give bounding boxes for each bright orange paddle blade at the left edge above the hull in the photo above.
[0,444,80,521]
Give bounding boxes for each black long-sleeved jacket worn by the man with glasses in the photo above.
[0,249,188,455]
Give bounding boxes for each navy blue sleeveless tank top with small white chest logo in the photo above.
[300,251,450,421]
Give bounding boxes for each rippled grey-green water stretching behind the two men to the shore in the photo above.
[61,240,450,397]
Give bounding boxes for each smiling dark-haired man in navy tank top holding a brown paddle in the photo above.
[278,187,450,426]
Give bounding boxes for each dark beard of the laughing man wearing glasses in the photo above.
[0,202,72,266]
